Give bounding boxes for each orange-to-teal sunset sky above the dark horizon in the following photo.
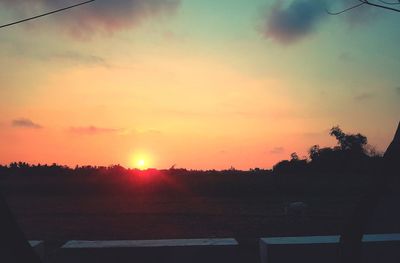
[0,0,400,169]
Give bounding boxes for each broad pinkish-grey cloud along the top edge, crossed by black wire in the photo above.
[0,0,180,39]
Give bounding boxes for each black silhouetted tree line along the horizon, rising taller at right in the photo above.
[0,126,383,176]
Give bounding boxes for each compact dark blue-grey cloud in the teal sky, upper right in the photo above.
[261,0,327,44]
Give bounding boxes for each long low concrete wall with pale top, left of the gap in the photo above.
[56,238,238,263]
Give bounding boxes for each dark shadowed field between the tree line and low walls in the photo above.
[0,174,400,240]
